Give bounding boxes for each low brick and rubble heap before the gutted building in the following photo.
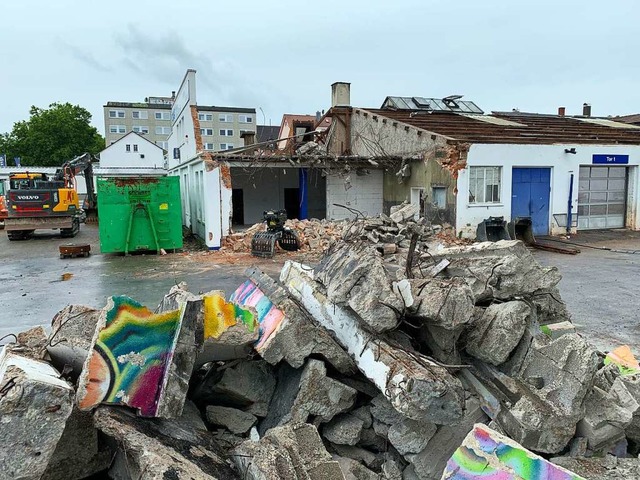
[223,203,446,255]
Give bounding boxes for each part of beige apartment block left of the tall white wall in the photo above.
[103,97,174,150]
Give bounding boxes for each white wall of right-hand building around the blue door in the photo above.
[456,144,640,238]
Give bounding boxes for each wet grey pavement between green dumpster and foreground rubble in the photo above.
[0,225,284,344]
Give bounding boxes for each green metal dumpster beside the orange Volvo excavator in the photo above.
[97,177,182,255]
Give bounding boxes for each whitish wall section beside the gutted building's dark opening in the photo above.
[327,170,383,220]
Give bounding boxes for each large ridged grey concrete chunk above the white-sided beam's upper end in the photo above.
[314,243,404,332]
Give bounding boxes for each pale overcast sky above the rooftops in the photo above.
[0,0,640,134]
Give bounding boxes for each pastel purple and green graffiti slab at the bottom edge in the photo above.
[442,425,584,480]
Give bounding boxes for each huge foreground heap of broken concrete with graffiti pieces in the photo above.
[0,232,640,480]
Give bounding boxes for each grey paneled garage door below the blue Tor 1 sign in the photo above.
[578,167,627,230]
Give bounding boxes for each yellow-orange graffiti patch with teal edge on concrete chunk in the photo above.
[203,293,258,338]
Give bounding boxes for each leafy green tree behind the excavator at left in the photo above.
[0,103,105,167]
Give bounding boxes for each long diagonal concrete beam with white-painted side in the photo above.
[281,262,464,424]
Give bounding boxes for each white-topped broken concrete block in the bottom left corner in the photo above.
[0,346,73,480]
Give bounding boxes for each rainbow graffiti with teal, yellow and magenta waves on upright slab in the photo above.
[78,296,181,417]
